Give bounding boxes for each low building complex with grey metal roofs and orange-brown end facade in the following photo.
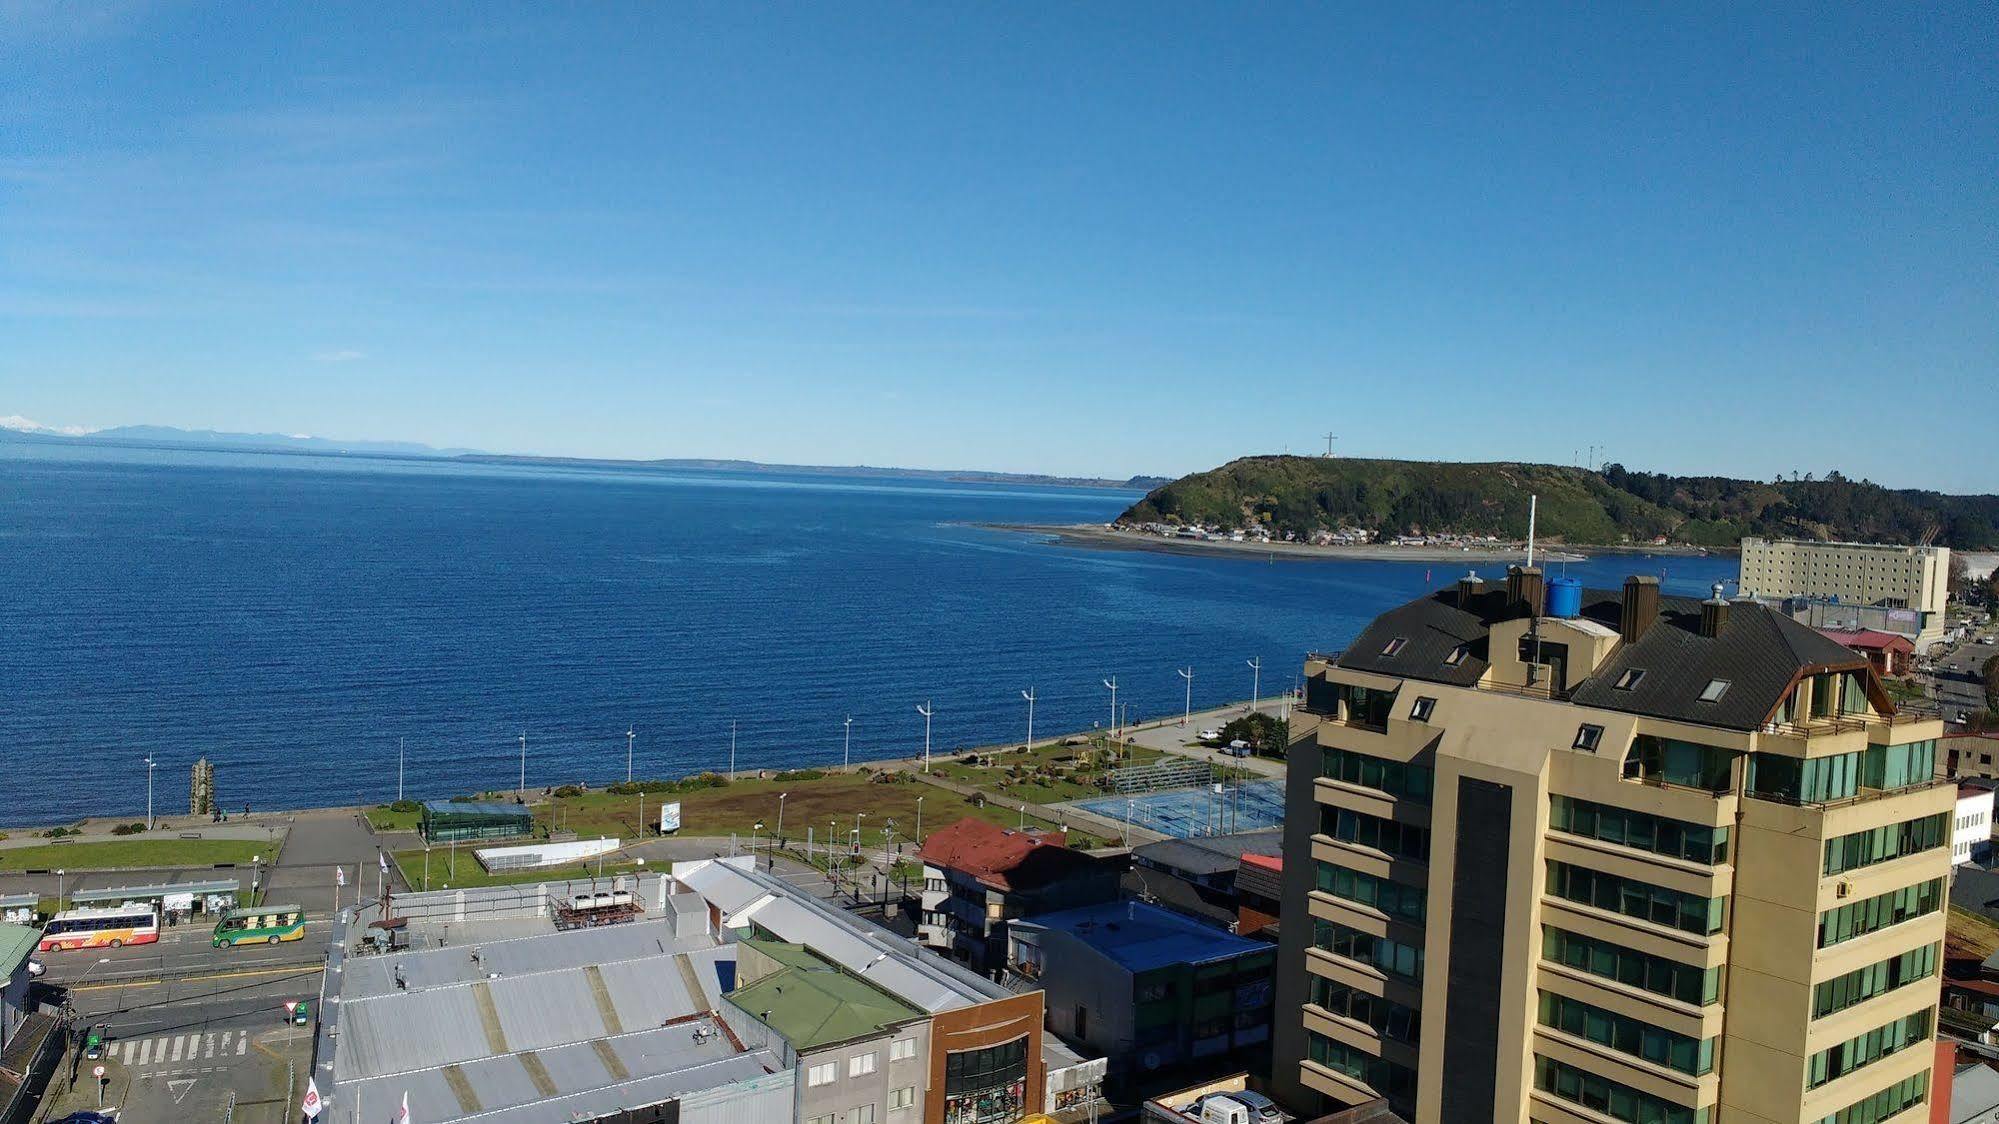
[316,858,1105,1124]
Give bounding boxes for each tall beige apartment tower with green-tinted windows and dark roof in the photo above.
[1273,568,1955,1124]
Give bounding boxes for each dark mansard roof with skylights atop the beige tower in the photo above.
[1339,584,1867,730]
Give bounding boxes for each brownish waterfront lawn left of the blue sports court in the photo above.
[536,770,1101,846]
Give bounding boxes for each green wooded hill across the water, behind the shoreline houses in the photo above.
[1117,456,1999,550]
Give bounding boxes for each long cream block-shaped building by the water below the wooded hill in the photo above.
[1739,538,1951,652]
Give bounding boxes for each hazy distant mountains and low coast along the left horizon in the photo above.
[0,416,1167,490]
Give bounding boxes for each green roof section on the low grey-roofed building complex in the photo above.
[730,940,924,1050]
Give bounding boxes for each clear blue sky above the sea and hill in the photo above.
[0,0,1999,490]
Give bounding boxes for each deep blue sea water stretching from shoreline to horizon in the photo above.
[0,444,1733,824]
